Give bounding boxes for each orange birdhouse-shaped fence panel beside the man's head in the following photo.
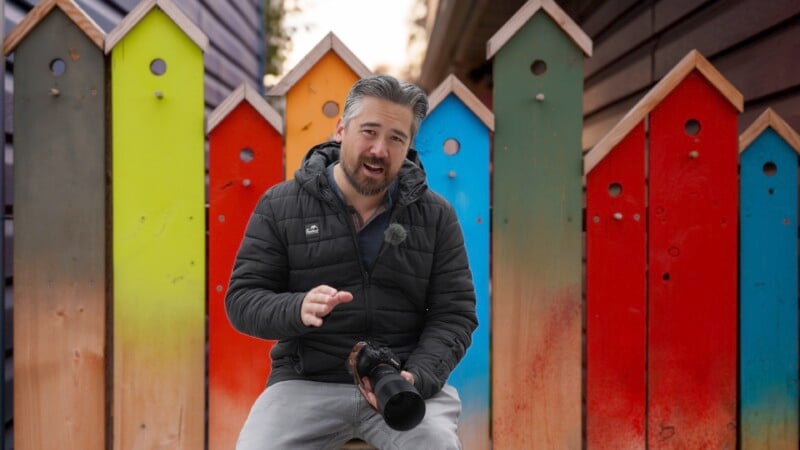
[285,51,359,179]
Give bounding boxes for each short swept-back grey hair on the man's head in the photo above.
[342,75,428,142]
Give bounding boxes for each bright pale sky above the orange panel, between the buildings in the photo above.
[283,0,414,75]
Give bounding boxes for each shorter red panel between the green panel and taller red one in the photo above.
[586,123,647,450]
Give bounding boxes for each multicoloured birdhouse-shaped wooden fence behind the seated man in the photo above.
[4,0,800,449]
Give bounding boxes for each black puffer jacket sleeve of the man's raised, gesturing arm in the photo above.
[225,191,310,339]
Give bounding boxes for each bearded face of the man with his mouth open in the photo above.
[336,97,414,196]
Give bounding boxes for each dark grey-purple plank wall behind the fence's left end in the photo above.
[3,0,265,449]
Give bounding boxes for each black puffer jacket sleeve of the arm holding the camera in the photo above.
[405,204,478,398]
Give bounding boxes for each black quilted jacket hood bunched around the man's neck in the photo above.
[294,141,428,204]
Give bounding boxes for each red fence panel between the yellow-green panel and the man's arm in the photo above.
[208,102,283,450]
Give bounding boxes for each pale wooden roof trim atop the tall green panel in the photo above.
[486,0,592,59]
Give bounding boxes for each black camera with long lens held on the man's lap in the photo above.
[346,342,425,431]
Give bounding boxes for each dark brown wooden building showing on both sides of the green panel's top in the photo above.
[418,0,800,150]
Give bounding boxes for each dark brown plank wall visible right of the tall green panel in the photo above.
[572,0,800,150]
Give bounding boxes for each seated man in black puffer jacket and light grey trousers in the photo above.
[225,75,477,450]
